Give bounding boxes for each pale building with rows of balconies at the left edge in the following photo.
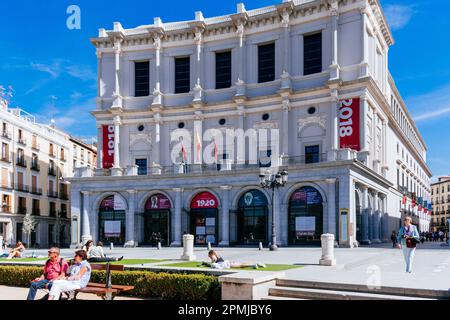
[0,97,95,247]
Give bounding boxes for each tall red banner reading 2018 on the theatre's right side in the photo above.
[338,98,361,151]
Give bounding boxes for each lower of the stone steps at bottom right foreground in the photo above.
[269,287,433,300]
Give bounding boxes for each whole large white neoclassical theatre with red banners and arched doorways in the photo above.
[71,0,431,247]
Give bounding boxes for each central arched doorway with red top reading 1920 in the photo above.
[190,192,219,245]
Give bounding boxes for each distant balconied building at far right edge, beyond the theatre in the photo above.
[431,176,450,233]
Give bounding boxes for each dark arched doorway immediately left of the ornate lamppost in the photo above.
[237,190,268,245]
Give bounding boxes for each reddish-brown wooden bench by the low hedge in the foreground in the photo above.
[72,263,134,300]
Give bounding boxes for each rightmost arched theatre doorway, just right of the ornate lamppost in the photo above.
[288,187,323,245]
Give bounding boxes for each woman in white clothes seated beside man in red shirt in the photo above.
[48,250,91,300]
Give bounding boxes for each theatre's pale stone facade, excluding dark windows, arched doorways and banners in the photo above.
[71,0,431,247]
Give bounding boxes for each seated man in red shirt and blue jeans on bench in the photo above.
[27,247,69,300]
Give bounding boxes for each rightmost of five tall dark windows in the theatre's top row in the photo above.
[303,32,322,76]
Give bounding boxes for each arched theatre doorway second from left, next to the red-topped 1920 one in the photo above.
[143,193,170,246]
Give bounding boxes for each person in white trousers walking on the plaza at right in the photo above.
[397,216,419,273]
